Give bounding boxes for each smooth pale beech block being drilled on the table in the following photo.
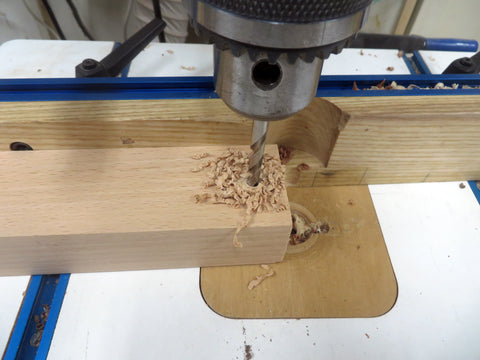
[0,146,291,275]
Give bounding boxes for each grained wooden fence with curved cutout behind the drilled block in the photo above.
[0,95,480,186]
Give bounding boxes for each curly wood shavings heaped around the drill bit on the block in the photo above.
[192,149,287,247]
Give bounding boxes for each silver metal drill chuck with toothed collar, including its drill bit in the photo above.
[183,0,372,186]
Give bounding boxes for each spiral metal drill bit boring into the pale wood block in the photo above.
[247,120,268,186]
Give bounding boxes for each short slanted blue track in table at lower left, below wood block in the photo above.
[4,274,70,360]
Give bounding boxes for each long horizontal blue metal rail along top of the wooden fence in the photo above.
[0,75,480,101]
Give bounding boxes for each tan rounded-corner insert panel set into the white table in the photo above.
[200,186,397,318]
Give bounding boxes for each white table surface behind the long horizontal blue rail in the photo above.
[0,40,410,78]
